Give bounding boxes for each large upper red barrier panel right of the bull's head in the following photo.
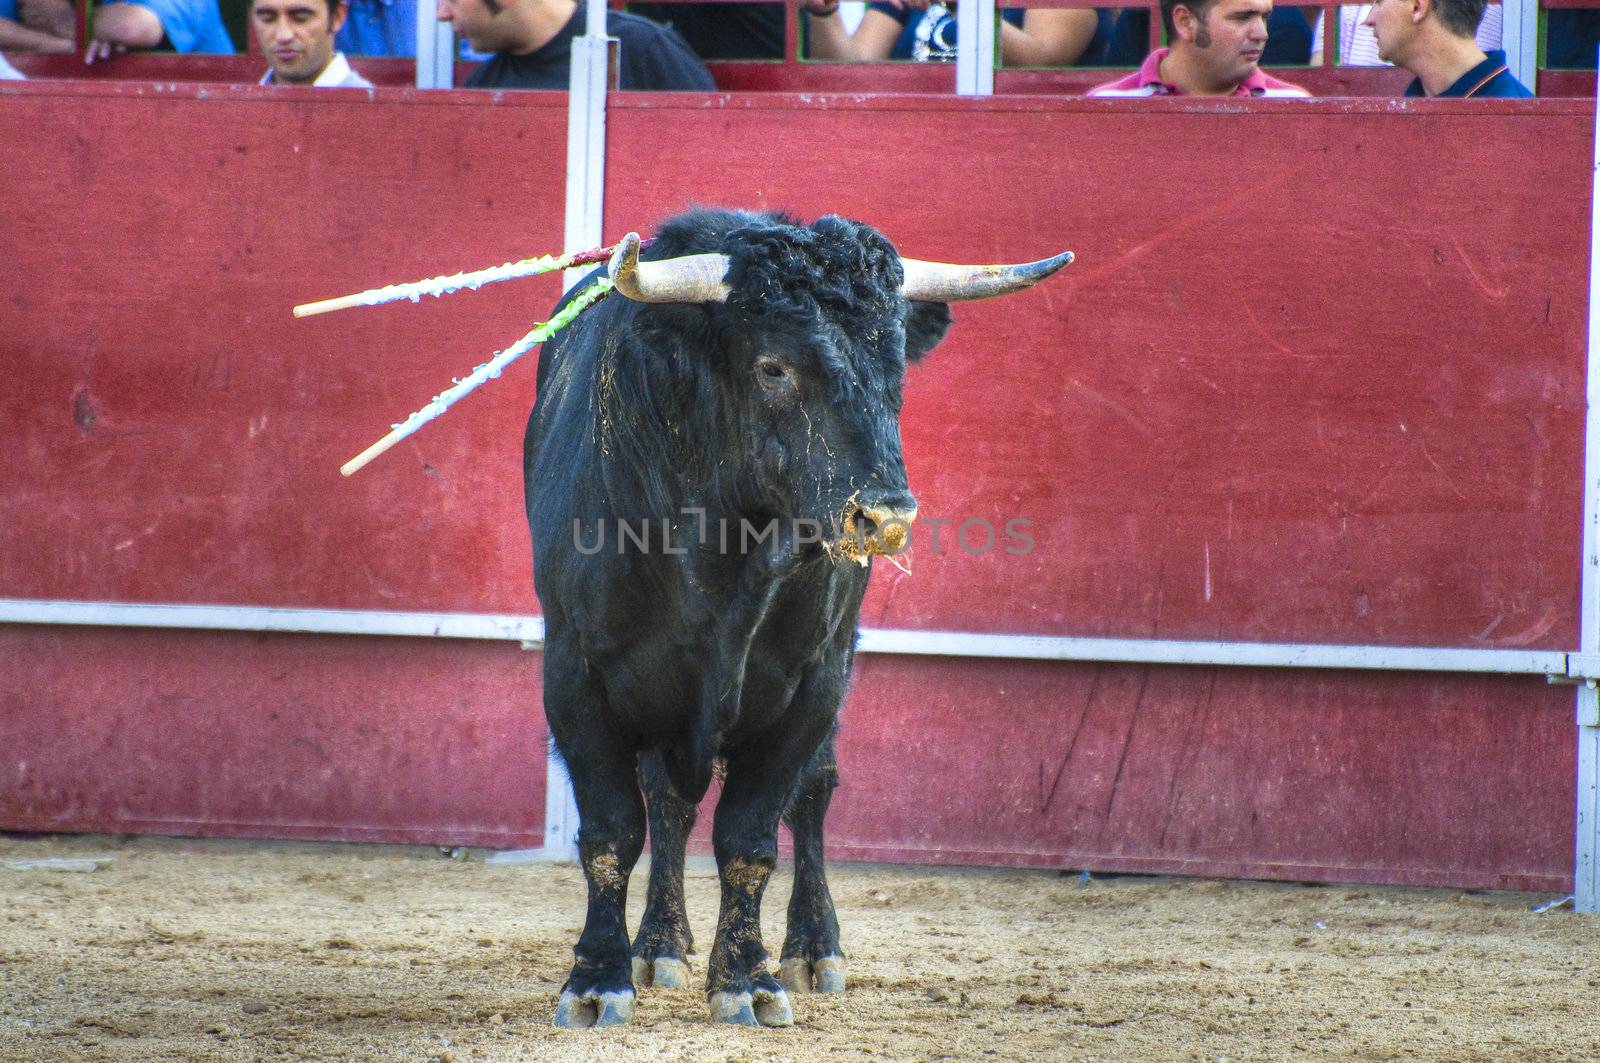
[606,98,1592,648]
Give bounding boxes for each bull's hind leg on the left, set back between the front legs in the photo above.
[634,752,696,989]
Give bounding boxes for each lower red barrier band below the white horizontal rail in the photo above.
[0,626,1574,890]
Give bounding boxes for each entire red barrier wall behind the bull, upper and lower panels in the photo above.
[0,85,1592,889]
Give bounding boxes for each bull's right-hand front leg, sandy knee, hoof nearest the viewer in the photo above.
[706,677,837,1026]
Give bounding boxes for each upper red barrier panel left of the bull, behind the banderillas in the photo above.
[0,85,566,613]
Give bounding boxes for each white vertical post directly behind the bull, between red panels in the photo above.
[544,0,610,861]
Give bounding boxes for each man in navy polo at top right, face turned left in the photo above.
[1363,0,1533,98]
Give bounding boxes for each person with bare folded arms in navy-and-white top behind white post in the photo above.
[808,0,1101,67]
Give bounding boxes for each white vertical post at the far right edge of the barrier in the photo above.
[1574,66,1600,911]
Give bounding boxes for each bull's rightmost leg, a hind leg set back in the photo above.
[778,735,845,993]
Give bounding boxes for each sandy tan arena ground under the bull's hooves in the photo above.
[0,837,1600,1063]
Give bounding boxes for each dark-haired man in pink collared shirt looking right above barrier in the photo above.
[1088,0,1310,96]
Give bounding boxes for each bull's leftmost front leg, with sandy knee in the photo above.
[544,644,645,1026]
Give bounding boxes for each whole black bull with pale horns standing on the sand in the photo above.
[525,211,1070,1026]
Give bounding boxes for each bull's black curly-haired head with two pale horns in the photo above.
[610,216,1072,565]
